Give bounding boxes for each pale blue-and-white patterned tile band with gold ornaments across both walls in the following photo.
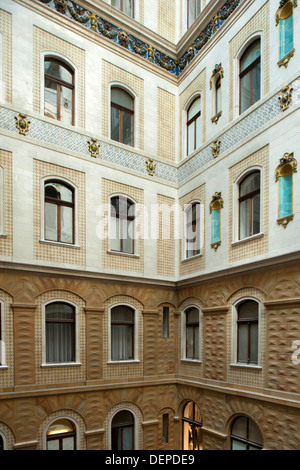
[0,78,300,185]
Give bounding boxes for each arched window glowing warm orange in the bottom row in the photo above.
[182,401,203,450]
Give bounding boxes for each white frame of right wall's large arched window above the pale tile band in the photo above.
[231,31,265,119]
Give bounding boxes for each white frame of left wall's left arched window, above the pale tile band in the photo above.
[40,50,79,129]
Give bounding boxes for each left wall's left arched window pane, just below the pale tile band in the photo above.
[45,181,74,244]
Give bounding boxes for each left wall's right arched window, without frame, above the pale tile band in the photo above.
[111,87,134,146]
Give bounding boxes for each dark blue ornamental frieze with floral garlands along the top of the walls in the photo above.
[38,0,243,76]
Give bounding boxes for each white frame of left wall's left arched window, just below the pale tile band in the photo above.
[40,175,80,248]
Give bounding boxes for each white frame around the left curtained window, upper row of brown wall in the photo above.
[41,298,81,367]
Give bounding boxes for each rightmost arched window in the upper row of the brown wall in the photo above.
[237,300,259,365]
